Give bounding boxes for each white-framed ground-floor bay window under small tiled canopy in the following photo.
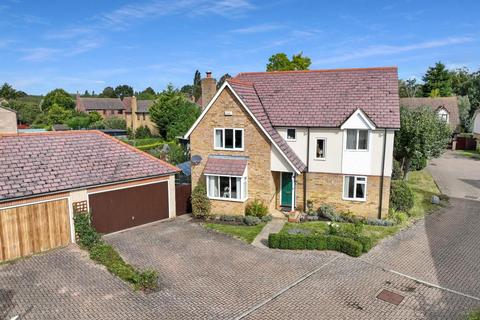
[206,175,248,201]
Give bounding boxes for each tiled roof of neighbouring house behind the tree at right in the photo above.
[400,97,460,129]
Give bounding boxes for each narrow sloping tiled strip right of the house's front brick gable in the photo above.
[227,79,306,172]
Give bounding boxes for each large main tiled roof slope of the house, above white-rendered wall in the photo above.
[231,67,400,129]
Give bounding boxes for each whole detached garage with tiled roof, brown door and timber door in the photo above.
[0,130,179,261]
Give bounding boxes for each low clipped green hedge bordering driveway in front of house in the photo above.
[268,233,364,257]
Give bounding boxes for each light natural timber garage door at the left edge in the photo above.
[0,199,70,261]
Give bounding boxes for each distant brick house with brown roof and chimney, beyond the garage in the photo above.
[76,95,158,134]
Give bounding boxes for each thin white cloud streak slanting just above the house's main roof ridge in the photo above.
[314,37,474,65]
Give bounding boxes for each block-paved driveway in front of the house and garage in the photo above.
[0,151,480,320]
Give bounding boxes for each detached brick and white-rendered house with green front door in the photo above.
[185,67,400,217]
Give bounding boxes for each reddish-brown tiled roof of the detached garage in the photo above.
[0,131,179,201]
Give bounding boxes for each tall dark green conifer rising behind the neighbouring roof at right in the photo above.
[423,62,453,97]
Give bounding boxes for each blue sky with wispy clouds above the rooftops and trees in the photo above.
[0,0,480,94]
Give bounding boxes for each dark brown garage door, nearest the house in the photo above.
[88,182,168,233]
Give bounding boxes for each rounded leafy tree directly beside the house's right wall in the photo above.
[394,107,451,179]
